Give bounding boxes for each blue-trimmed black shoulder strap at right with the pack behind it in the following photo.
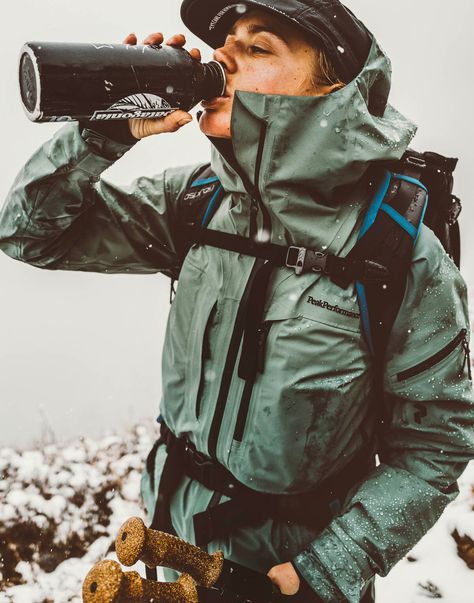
[346,149,461,363]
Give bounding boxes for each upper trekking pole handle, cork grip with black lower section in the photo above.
[115,517,293,603]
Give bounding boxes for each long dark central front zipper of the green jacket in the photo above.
[208,124,271,458]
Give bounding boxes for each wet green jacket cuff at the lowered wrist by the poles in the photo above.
[293,522,374,603]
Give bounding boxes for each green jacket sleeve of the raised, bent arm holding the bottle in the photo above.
[0,123,204,274]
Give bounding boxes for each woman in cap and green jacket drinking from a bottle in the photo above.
[0,0,473,603]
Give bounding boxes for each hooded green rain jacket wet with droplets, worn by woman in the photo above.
[0,41,474,603]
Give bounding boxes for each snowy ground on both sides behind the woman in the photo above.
[0,422,474,603]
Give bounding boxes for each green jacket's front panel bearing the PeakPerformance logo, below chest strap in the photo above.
[230,269,371,489]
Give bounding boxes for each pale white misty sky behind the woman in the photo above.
[0,0,474,447]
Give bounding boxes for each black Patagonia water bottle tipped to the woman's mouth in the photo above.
[19,42,226,122]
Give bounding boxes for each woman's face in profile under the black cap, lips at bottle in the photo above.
[199,10,333,138]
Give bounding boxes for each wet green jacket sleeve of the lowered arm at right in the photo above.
[293,228,474,603]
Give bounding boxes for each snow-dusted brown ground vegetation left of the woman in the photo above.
[0,422,158,603]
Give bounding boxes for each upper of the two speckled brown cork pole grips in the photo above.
[115,517,224,588]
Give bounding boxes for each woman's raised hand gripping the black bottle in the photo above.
[123,33,201,140]
